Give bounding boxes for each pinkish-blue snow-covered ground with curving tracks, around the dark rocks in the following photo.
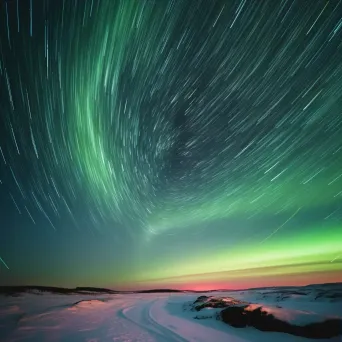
[0,289,342,342]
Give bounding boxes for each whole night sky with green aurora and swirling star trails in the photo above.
[0,0,342,289]
